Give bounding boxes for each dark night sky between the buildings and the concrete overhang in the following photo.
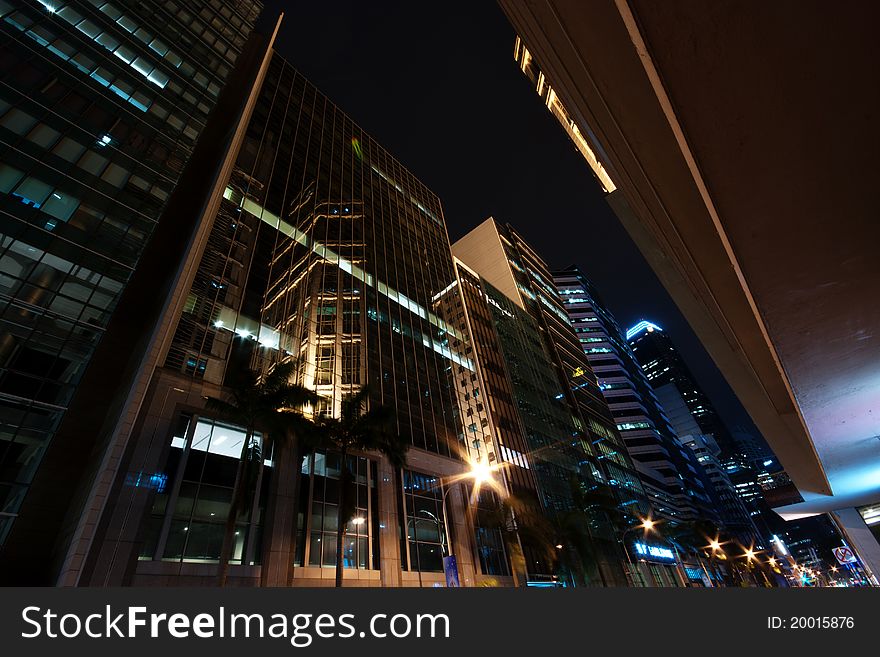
[267,0,755,440]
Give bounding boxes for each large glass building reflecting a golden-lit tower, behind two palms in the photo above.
[84,47,513,586]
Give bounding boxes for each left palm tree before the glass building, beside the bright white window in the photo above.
[207,361,317,586]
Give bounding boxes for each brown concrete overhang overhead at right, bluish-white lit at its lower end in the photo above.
[500,0,880,517]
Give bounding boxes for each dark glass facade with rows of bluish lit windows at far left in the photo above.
[0,0,261,544]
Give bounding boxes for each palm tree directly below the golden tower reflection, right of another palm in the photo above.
[314,386,409,586]
